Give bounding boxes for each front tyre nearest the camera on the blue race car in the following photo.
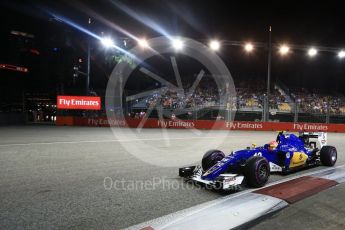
[244,156,270,188]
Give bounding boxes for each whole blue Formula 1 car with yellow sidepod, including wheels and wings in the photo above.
[179,132,337,190]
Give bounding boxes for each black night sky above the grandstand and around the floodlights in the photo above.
[0,0,345,98]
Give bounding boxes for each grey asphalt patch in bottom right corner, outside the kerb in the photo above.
[250,183,345,230]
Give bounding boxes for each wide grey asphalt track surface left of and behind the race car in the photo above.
[0,126,345,229]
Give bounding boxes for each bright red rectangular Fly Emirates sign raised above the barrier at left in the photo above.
[57,96,101,110]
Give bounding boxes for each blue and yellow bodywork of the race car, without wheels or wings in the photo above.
[201,133,315,180]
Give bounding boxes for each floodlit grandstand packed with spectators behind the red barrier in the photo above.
[128,77,345,122]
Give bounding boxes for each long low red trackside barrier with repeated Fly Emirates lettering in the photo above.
[56,116,345,132]
